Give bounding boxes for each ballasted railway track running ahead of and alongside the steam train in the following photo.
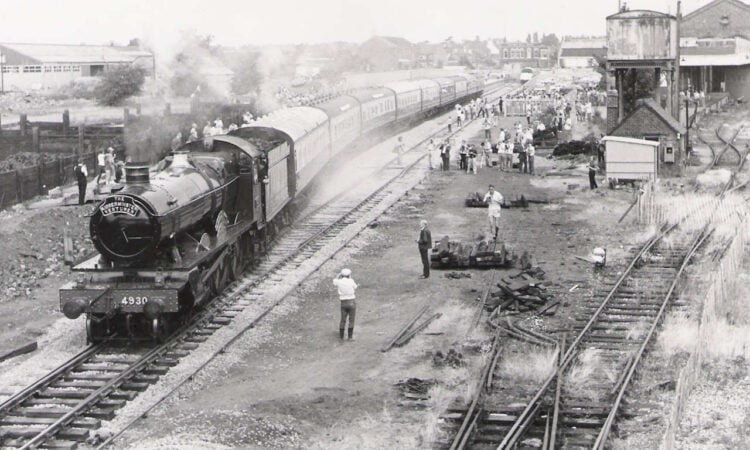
[0,83,504,449]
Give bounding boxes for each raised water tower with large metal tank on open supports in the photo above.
[607,6,680,131]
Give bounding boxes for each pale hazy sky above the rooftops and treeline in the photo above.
[0,0,710,51]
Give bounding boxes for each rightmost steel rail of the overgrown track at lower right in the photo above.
[594,228,711,450]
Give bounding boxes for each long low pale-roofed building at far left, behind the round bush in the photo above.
[0,43,155,91]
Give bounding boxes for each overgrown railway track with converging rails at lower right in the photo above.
[444,222,709,450]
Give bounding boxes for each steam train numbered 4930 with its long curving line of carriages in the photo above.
[60,76,484,342]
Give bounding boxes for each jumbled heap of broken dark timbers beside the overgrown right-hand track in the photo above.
[486,267,558,315]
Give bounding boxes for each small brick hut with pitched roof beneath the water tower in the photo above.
[607,98,685,176]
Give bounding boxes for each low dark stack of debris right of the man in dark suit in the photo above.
[430,236,531,269]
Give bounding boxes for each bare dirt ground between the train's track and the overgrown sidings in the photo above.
[111,115,633,449]
